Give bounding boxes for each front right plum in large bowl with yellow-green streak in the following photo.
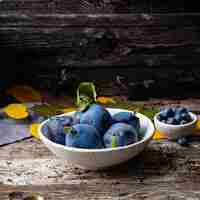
[103,122,138,148]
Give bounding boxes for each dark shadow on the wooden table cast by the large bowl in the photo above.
[74,144,177,181]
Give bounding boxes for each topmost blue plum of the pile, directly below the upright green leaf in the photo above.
[80,104,112,136]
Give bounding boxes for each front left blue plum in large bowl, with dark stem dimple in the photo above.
[65,124,103,149]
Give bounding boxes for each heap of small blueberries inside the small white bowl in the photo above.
[157,107,192,125]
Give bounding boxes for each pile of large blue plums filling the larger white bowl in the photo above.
[42,104,140,149]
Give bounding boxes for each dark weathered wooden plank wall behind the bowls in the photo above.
[0,0,200,98]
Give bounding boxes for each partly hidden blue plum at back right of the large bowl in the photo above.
[112,112,140,131]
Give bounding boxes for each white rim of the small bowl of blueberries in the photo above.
[154,111,197,128]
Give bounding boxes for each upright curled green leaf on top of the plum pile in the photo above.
[76,82,97,110]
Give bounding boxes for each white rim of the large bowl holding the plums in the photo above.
[38,107,155,153]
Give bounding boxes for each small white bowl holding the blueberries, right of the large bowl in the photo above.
[154,112,197,140]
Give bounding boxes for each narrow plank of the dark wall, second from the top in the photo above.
[0,13,200,28]
